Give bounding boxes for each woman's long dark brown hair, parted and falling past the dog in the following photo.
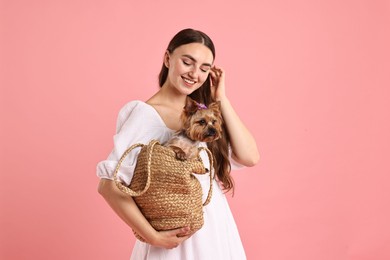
[158,29,234,191]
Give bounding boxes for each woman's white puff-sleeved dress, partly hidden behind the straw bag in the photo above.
[97,101,246,260]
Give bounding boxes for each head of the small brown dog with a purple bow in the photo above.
[181,97,222,142]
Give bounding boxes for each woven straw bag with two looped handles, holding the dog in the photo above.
[114,140,213,241]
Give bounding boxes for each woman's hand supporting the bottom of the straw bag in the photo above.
[151,227,192,249]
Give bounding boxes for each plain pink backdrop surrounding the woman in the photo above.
[0,0,390,260]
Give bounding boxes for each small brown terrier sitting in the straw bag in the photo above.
[164,97,222,161]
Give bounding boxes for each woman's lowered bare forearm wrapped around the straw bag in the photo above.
[98,179,158,244]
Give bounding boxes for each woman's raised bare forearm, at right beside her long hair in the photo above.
[220,97,260,166]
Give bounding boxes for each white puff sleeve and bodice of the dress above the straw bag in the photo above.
[96,101,172,185]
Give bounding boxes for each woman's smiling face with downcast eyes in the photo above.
[164,43,214,95]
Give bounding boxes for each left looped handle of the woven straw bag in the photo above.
[114,140,158,197]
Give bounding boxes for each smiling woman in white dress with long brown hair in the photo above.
[97,29,259,260]
